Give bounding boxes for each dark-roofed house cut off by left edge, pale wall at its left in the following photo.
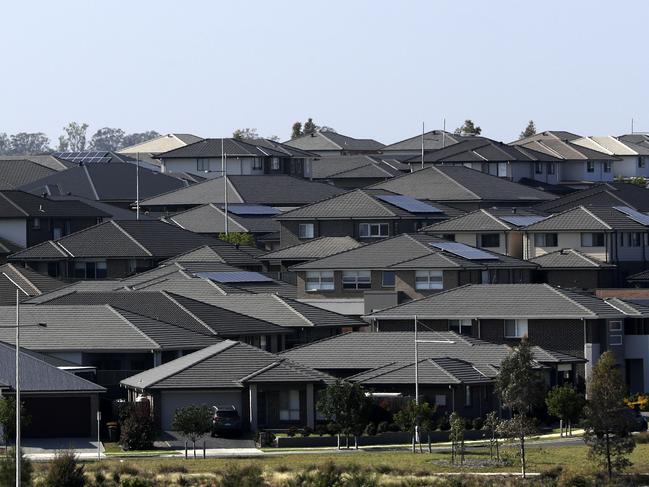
[0,190,112,248]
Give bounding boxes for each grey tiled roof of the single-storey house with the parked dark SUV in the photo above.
[122,340,333,390]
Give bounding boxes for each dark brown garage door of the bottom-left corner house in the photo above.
[22,397,92,438]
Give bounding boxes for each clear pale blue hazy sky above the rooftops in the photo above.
[0,0,649,143]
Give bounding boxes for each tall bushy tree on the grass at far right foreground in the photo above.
[584,352,635,478]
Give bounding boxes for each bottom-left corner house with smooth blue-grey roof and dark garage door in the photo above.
[0,342,106,438]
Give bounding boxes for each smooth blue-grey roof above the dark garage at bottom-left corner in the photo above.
[0,342,106,394]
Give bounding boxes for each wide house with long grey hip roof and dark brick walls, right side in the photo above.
[365,284,646,382]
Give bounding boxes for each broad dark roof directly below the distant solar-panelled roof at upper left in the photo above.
[20,163,188,203]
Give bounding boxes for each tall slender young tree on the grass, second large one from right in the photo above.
[496,338,545,478]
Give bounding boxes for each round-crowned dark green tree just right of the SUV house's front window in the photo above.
[317,380,372,449]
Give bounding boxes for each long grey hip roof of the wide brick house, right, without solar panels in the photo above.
[370,284,623,319]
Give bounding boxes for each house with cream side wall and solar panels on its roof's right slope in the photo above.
[421,208,546,259]
